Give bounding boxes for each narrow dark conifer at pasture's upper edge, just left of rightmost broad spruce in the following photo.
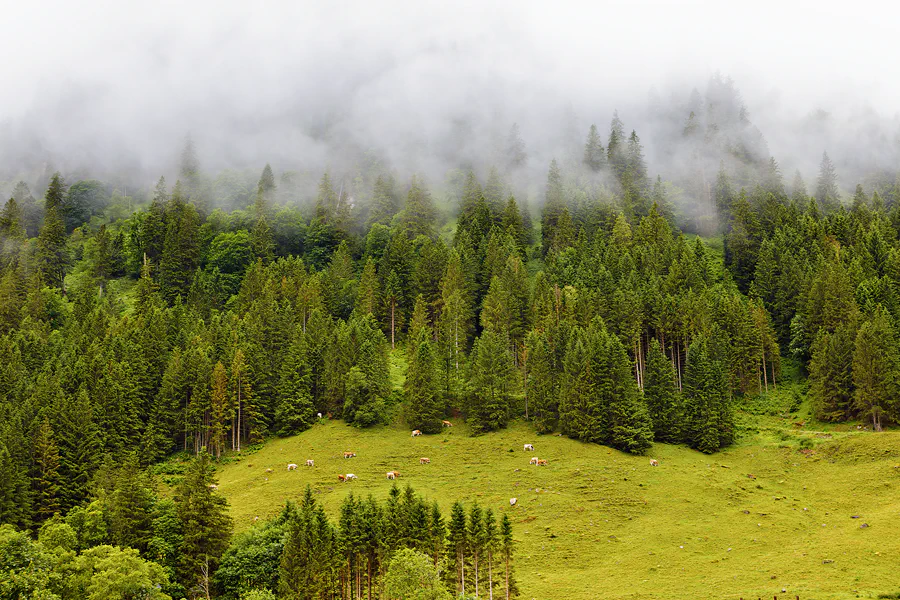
[644,339,682,444]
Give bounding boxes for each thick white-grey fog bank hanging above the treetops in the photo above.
[0,2,900,202]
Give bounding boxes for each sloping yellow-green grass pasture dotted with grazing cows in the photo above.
[219,406,900,600]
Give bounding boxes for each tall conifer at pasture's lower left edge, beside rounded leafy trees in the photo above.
[175,452,232,596]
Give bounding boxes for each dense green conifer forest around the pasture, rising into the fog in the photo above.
[0,80,900,599]
